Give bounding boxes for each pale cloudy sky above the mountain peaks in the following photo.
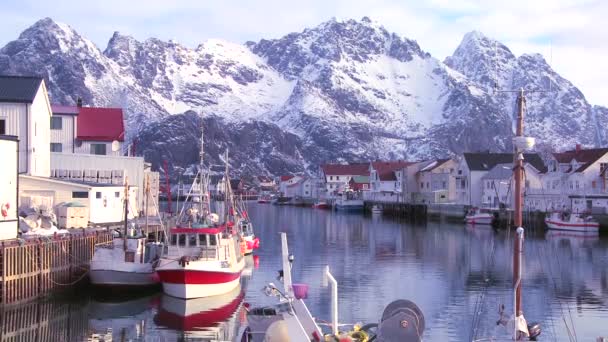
[0,0,608,106]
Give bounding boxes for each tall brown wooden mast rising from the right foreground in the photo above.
[513,89,526,319]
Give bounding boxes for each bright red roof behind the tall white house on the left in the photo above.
[76,107,125,141]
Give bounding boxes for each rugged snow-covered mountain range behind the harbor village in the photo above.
[0,18,608,174]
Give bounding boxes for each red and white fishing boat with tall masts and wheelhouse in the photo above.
[156,130,245,299]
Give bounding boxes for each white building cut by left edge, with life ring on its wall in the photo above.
[0,135,19,240]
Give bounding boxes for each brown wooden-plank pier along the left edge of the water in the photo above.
[0,230,112,304]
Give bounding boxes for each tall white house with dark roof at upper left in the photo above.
[0,76,51,177]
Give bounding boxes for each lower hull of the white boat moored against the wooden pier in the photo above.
[89,269,160,287]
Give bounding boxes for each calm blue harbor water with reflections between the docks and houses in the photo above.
[0,203,608,341]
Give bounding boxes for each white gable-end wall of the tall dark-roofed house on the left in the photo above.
[28,81,52,177]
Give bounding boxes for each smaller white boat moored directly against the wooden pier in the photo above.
[89,182,163,288]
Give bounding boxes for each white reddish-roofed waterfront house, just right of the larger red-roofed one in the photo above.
[369,160,414,202]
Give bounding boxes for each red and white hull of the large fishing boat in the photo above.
[158,269,242,299]
